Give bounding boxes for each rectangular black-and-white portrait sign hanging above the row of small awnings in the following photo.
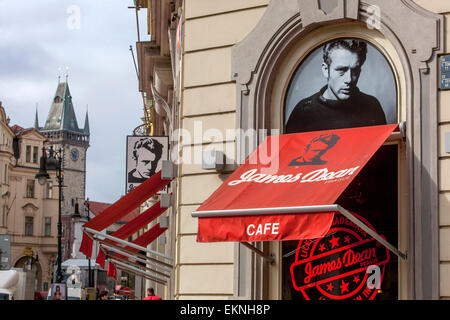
[127,136,168,192]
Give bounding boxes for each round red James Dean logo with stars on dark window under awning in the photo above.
[291,213,390,300]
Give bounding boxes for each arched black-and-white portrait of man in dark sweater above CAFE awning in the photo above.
[285,39,397,133]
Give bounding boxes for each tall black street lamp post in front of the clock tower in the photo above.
[35,146,63,283]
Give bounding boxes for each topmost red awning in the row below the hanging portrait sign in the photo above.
[80,171,171,257]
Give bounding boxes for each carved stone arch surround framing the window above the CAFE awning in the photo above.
[231,0,444,299]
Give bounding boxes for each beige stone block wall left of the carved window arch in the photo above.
[175,0,269,299]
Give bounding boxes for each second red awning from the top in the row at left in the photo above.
[96,201,167,268]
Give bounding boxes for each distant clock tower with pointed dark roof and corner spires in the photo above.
[34,80,90,261]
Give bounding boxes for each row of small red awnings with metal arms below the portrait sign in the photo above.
[80,171,173,283]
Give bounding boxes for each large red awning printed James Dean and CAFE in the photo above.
[192,124,398,242]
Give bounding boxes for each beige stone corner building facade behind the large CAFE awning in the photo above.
[129,0,450,300]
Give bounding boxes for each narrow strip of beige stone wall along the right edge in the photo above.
[415,0,450,299]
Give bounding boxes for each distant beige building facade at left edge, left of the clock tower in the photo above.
[0,102,58,291]
